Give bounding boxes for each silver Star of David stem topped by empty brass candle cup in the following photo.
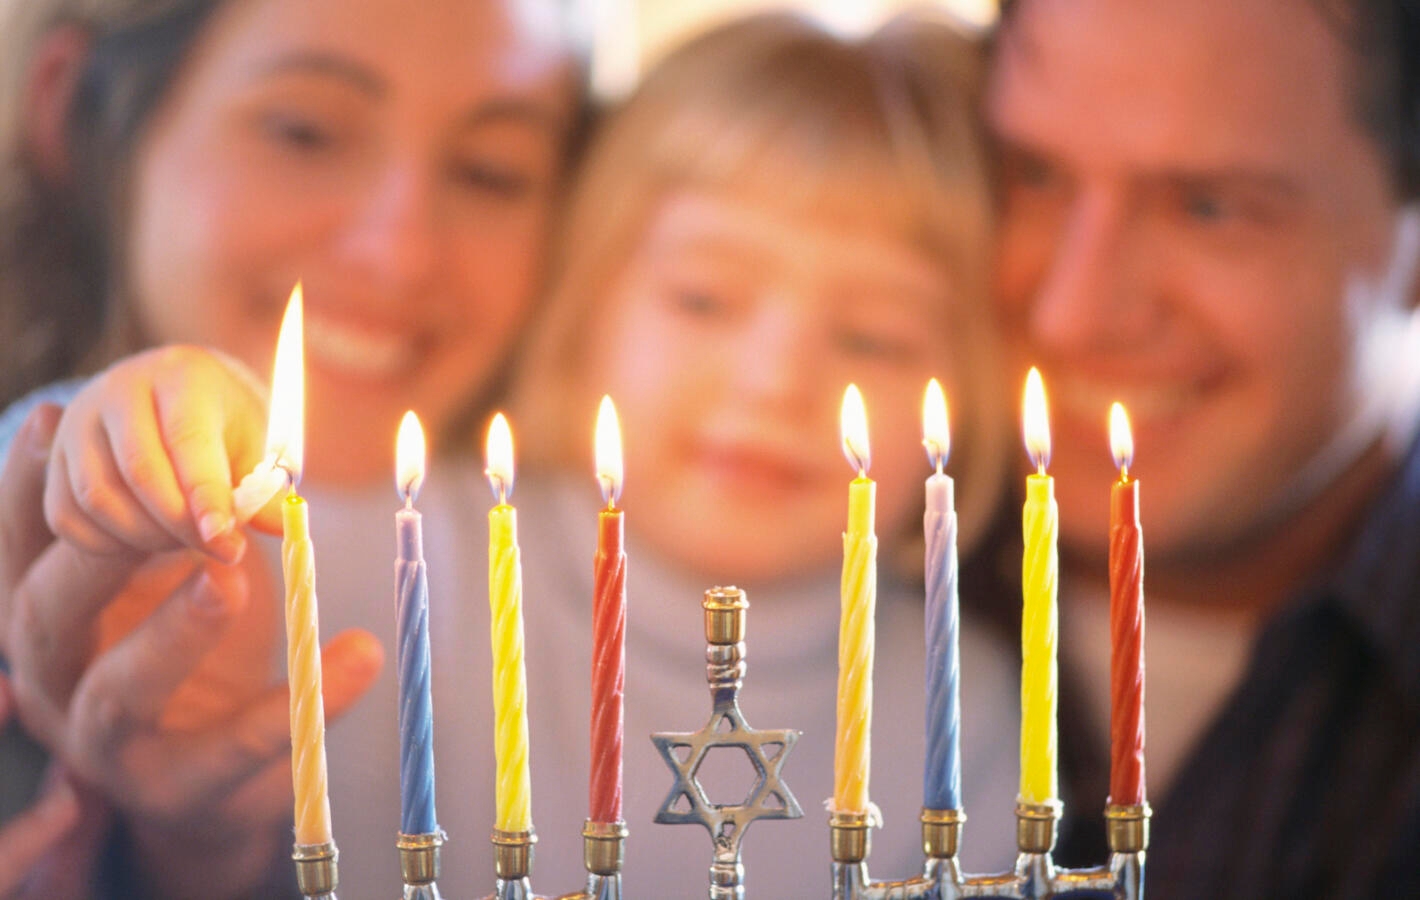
[650,588,804,900]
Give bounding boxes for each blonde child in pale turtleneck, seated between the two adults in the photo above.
[514,16,1017,897]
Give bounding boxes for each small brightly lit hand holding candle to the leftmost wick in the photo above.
[44,346,280,565]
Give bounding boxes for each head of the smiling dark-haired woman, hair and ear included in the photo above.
[0,0,575,481]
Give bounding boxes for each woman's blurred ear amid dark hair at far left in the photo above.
[21,26,89,185]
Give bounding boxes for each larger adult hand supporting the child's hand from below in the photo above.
[0,407,382,896]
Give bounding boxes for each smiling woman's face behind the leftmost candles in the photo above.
[128,0,574,483]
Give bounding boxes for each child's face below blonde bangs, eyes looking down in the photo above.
[589,190,950,583]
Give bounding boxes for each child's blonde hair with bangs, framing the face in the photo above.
[515,13,1003,550]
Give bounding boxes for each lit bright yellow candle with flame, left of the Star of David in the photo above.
[487,413,533,832]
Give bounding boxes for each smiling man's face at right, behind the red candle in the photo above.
[987,0,1414,561]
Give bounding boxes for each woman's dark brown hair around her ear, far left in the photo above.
[0,0,220,405]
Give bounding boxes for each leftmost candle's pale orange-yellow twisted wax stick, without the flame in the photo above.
[281,491,331,843]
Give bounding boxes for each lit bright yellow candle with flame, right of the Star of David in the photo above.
[1021,368,1059,803]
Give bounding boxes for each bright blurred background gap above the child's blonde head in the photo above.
[584,0,997,97]
